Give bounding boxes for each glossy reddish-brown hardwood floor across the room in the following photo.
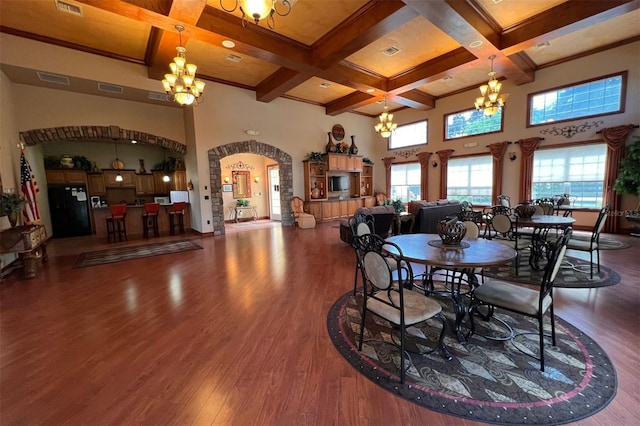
[0,222,640,426]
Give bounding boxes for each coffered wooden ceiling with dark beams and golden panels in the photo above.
[0,0,640,116]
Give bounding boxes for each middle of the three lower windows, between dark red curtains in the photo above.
[447,155,493,206]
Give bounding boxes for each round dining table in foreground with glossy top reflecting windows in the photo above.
[385,234,516,342]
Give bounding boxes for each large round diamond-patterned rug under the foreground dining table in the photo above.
[327,292,617,425]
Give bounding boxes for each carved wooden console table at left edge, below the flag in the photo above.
[0,225,48,280]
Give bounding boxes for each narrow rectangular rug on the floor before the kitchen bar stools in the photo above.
[73,240,202,268]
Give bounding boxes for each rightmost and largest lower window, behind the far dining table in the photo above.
[531,144,607,209]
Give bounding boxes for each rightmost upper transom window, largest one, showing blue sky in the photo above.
[528,71,627,126]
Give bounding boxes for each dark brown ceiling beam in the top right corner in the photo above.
[500,0,640,55]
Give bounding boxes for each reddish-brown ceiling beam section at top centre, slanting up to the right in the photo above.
[311,0,418,69]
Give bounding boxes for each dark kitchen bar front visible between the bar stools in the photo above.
[92,204,191,241]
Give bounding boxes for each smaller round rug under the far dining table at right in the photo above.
[484,252,621,288]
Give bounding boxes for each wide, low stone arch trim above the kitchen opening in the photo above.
[19,126,187,154]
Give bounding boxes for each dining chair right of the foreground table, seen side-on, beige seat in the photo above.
[467,227,572,371]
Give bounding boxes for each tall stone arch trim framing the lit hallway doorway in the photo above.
[208,140,293,235]
